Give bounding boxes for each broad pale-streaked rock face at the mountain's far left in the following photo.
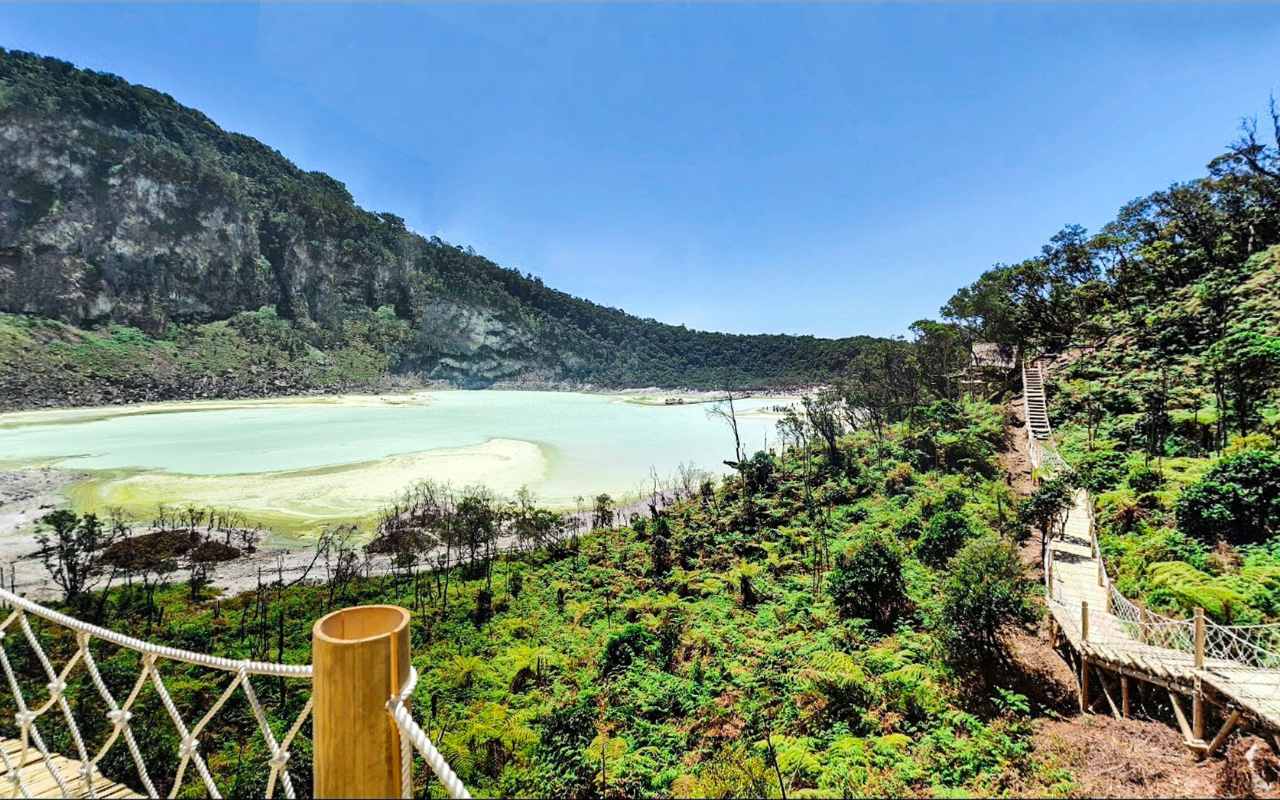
[0,115,275,321]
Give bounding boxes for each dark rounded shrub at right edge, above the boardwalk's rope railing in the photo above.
[1176,451,1280,544]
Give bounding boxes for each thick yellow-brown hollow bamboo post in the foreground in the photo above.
[311,605,410,797]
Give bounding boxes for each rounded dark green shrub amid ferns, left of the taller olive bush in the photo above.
[827,530,909,631]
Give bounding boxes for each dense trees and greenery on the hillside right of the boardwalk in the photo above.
[926,104,1280,622]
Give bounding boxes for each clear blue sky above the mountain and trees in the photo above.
[0,4,1280,335]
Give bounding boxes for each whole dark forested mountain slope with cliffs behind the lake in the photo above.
[0,50,869,402]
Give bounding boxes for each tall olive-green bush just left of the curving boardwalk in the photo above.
[938,536,1037,663]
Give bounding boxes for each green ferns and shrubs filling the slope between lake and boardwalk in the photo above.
[0,401,1070,797]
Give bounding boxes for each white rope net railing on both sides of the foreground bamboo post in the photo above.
[0,589,470,800]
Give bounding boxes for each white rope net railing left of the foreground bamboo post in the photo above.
[0,581,311,799]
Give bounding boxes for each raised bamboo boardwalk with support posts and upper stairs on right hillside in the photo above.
[1023,365,1280,753]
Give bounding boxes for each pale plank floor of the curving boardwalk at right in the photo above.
[1050,492,1280,731]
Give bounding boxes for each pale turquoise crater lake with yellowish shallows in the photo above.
[0,390,786,521]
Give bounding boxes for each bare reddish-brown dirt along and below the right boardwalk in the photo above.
[998,397,1224,797]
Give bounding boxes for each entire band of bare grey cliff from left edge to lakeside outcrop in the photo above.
[0,107,575,384]
